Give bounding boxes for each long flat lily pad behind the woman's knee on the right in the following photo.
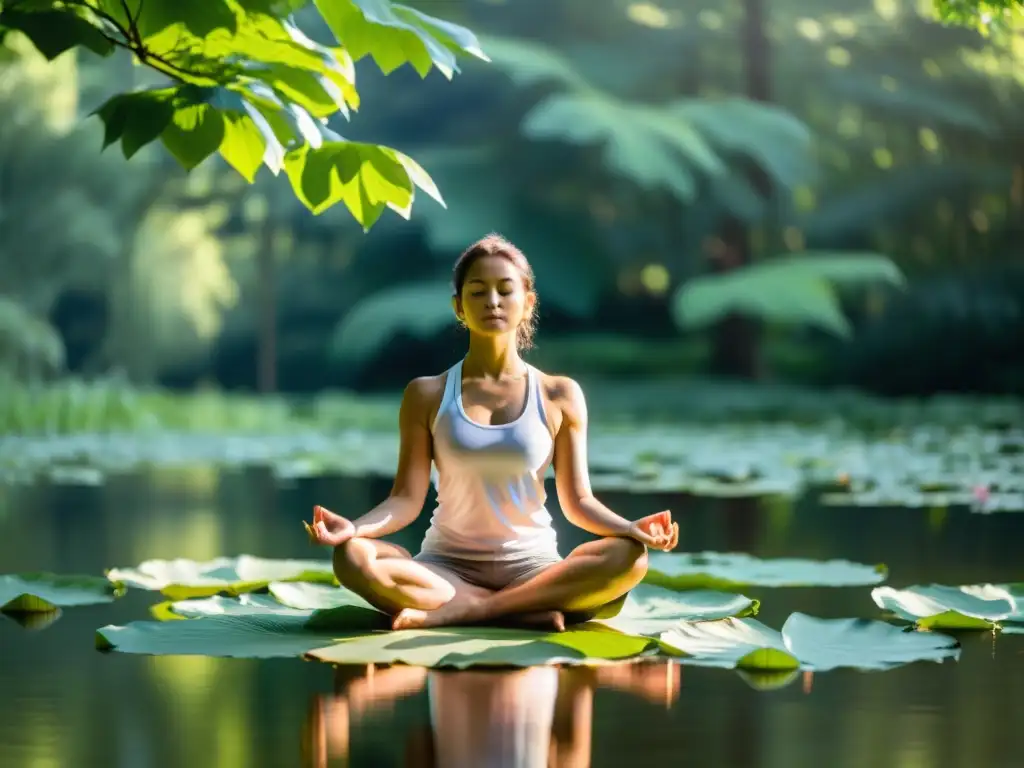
[644,552,888,591]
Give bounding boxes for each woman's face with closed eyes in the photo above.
[455,255,537,336]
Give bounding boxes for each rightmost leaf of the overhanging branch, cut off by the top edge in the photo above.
[315,0,486,79]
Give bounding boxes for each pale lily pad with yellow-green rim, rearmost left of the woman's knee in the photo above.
[106,555,335,600]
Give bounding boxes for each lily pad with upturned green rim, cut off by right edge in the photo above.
[871,584,1024,630]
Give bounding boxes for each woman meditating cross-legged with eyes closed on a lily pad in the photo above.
[306,236,679,631]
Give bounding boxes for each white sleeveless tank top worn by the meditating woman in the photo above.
[422,360,558,560]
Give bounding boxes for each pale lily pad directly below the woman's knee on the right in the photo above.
[601,584,761,636]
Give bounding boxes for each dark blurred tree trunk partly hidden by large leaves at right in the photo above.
[711,0,772,379]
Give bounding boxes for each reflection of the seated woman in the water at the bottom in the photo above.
[303,662,682,768]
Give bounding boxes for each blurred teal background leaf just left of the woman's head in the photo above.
[331,283,456,366]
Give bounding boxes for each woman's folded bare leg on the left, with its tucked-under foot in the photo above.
[334,539,564,631]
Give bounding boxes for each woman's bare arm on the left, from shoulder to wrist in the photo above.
[353,376,443,539]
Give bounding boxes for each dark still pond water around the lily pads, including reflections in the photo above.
[0,470,1024,768]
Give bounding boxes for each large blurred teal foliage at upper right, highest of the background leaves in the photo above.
[485,38,813,219]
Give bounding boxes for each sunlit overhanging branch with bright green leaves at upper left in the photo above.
[0,0,486,229]
